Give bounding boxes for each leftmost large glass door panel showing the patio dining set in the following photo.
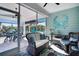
[0,3,18,55]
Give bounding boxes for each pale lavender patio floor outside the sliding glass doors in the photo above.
[0,39,28,53]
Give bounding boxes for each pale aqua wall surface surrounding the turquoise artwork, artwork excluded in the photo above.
[47,6,79,34]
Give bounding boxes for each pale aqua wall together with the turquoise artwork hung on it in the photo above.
[47,6,79,35]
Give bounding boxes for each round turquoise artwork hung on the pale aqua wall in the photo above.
[53,15,68,30]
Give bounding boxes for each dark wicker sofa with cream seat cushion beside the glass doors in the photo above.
[26,33,49,56]
